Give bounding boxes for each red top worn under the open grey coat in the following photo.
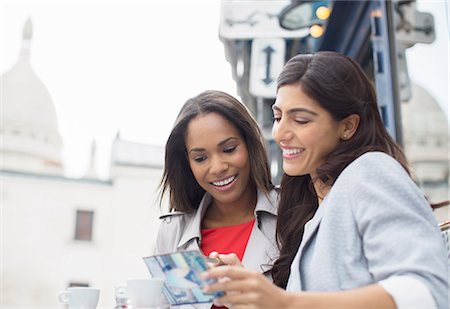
[200,219,255,309]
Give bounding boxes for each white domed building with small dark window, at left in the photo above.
[0,21,164,308]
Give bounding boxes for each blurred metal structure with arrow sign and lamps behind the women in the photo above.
[219,0,434,183]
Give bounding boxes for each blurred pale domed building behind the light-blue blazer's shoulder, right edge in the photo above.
[402,84,450,222]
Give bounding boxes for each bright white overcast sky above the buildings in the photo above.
[0,0,450,178]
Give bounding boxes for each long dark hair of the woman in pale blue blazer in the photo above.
[272,52,409,287]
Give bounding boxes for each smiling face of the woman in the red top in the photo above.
[185,113,252,203]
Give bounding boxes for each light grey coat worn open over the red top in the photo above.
[155,190,279,309]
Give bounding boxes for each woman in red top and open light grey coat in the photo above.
[156,91,278,308]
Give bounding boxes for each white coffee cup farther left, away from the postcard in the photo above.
[58,287,100,309]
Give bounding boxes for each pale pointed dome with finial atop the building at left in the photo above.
[0,20,62,172]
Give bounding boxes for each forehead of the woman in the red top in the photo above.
[185,112,241,148]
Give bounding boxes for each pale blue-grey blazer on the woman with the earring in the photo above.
[287,152,449,308]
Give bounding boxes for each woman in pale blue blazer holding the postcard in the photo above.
[205,52,449,309]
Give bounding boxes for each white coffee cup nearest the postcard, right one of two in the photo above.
[126,278,164,308]
